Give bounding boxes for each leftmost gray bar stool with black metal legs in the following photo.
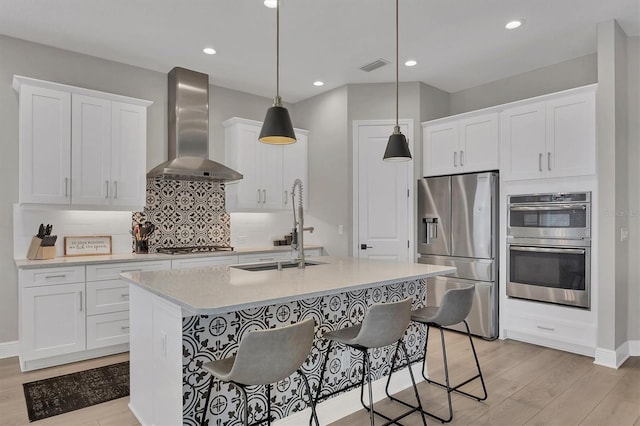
[200,318,320,426]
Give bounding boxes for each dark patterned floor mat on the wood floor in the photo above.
[22,361,129,422]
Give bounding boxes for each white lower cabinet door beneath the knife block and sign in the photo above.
[20,282,85,361]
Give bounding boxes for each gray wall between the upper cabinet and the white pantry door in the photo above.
[291,86,352,256]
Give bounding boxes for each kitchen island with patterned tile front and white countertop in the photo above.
[122,256,455,425]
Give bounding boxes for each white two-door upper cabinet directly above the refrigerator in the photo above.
[422,112,499,176]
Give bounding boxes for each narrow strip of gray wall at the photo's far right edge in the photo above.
[627,37,640,341]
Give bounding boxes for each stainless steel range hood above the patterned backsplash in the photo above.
[147,67,242,182]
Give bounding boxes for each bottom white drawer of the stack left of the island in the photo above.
[87,312,129,349]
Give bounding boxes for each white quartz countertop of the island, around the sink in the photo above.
[121,256,456,316]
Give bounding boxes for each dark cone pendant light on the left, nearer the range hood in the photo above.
[259,0,296,145]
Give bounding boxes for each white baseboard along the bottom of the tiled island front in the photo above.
[274,362,424,426]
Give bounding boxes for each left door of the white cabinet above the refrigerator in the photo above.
[422,120,460,176]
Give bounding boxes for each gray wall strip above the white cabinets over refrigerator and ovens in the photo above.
[451,53,598,114]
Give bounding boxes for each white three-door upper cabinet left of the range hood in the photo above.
[13,76,151,210]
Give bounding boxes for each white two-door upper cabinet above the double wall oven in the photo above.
[500,85,596,180]
